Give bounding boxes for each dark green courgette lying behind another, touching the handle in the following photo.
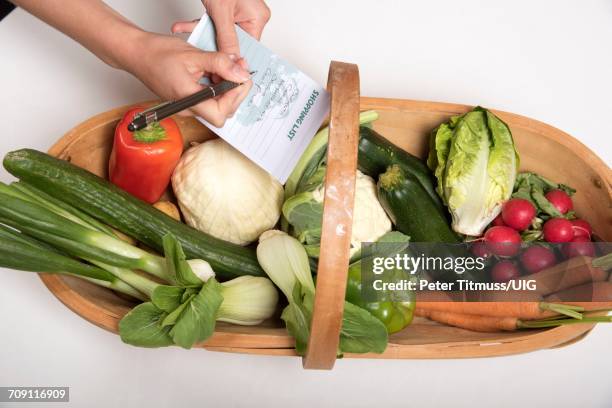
[359,126,447,217]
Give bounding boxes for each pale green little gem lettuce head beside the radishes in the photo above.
[427,107,519,236]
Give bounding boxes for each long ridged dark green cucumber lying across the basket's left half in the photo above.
[3,149,265,279]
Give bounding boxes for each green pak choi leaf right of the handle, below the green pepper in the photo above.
[339,302,389,353]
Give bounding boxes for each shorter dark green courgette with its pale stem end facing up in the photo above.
[378,164,460,243]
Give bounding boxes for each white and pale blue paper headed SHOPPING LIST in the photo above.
[187,15,329,183]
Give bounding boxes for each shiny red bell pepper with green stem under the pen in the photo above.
[108,107,183,203]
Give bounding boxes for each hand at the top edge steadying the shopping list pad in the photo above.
[172,0,270,55]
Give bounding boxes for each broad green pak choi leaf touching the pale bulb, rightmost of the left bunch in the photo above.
[170,278,223,349]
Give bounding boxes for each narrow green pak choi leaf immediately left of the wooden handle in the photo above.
[281,282,314,356]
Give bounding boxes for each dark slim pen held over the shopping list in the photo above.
[128,71,256,132]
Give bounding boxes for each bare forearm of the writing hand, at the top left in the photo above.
[11,0,145,70]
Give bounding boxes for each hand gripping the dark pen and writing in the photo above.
[122,33,252,127]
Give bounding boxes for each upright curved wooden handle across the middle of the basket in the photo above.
[303,61,359,370]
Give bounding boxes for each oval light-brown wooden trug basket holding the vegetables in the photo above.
[40,62,612,369]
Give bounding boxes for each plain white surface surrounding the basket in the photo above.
[0,0,612,408]
